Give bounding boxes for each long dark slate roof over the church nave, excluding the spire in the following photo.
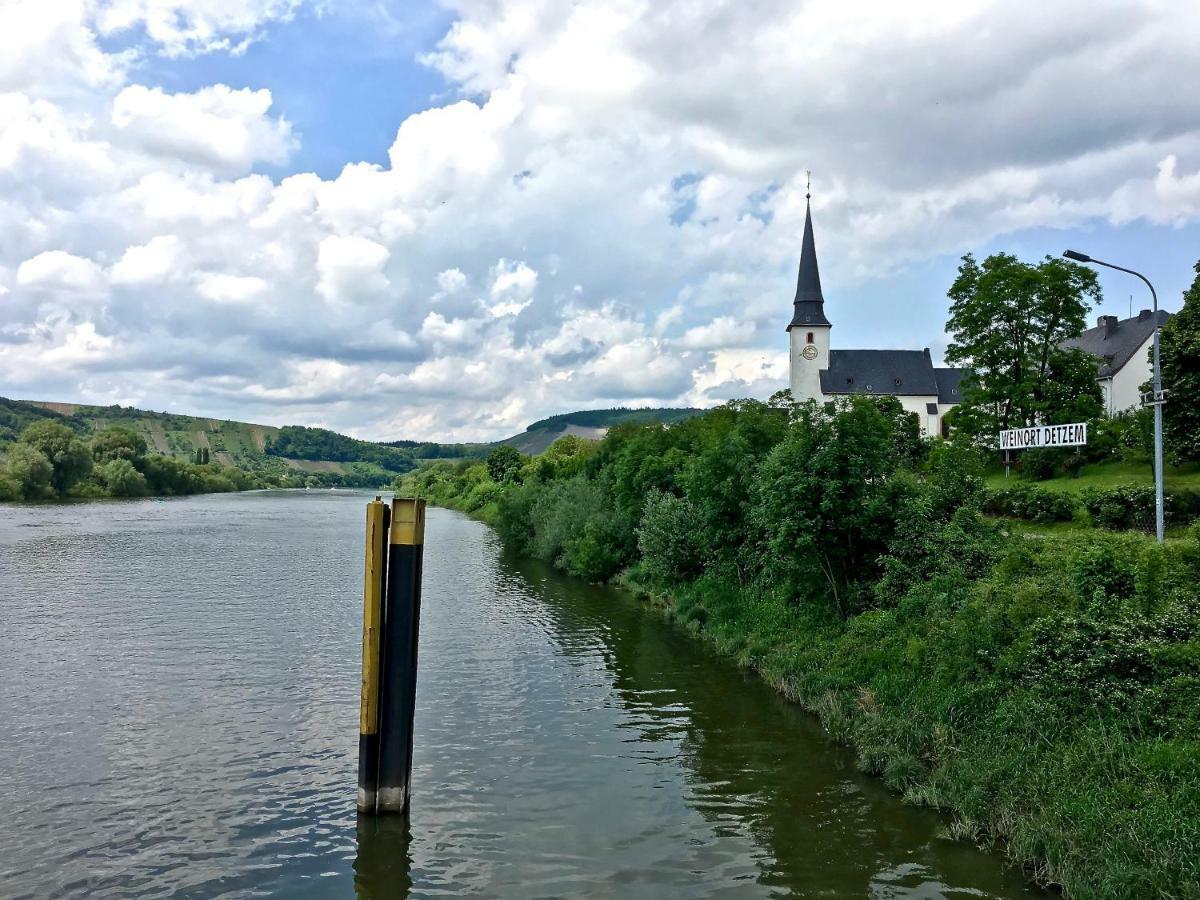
[821,349,966,403]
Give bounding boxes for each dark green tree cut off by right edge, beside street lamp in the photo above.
[1151,262,1200,460]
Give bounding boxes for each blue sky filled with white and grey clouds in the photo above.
[0,0,1200,440]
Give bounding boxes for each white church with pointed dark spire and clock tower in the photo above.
[787,196,967,436]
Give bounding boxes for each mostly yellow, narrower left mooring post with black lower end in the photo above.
[358,497,389,812]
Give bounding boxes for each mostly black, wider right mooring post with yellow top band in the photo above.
[376,497,425,812]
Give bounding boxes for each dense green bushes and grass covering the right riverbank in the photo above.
[396,394,1200,898]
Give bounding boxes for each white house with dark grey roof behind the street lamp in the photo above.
[1063,310,1171,415]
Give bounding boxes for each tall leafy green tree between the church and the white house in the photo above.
[946,253,1103,436]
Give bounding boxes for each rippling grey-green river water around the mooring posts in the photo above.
[0,492,1046,898]
